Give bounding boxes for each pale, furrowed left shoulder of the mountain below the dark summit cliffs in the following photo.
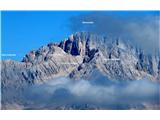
[1,46,82,84]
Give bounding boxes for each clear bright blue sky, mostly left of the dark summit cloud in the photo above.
[1,11,157,60]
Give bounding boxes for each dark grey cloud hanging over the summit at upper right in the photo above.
[70,11,160,53]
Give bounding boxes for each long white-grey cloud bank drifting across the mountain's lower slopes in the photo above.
[24,78,160,109]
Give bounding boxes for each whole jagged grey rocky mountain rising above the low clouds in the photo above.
[1,32,160,109]
